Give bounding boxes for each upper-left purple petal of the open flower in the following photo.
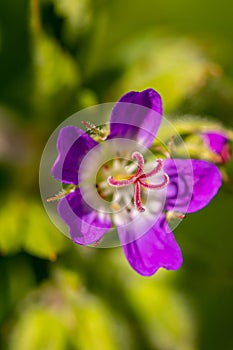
[52,126,97,184]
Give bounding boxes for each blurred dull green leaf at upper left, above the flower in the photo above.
[32,33,80,120]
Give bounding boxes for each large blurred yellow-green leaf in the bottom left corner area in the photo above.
[9,269,129,350]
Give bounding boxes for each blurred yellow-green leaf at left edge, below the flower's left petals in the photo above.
[0,196,69,260]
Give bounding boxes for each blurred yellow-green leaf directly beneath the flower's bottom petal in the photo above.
[126,271,196,350]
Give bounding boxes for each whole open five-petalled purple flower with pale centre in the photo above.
[52,89,221,276]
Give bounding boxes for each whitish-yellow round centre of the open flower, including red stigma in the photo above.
[79,139,169,230]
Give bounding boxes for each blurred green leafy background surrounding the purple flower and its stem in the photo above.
[0,0,233,350]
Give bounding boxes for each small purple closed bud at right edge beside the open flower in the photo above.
[201,131,231,164]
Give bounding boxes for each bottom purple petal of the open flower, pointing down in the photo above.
[118,214,182,276]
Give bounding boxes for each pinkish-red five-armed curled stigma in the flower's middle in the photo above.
[107,152,169,212]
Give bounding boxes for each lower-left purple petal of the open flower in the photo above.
[58,189,112,245]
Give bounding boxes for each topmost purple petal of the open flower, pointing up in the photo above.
[108,89,162,147]
